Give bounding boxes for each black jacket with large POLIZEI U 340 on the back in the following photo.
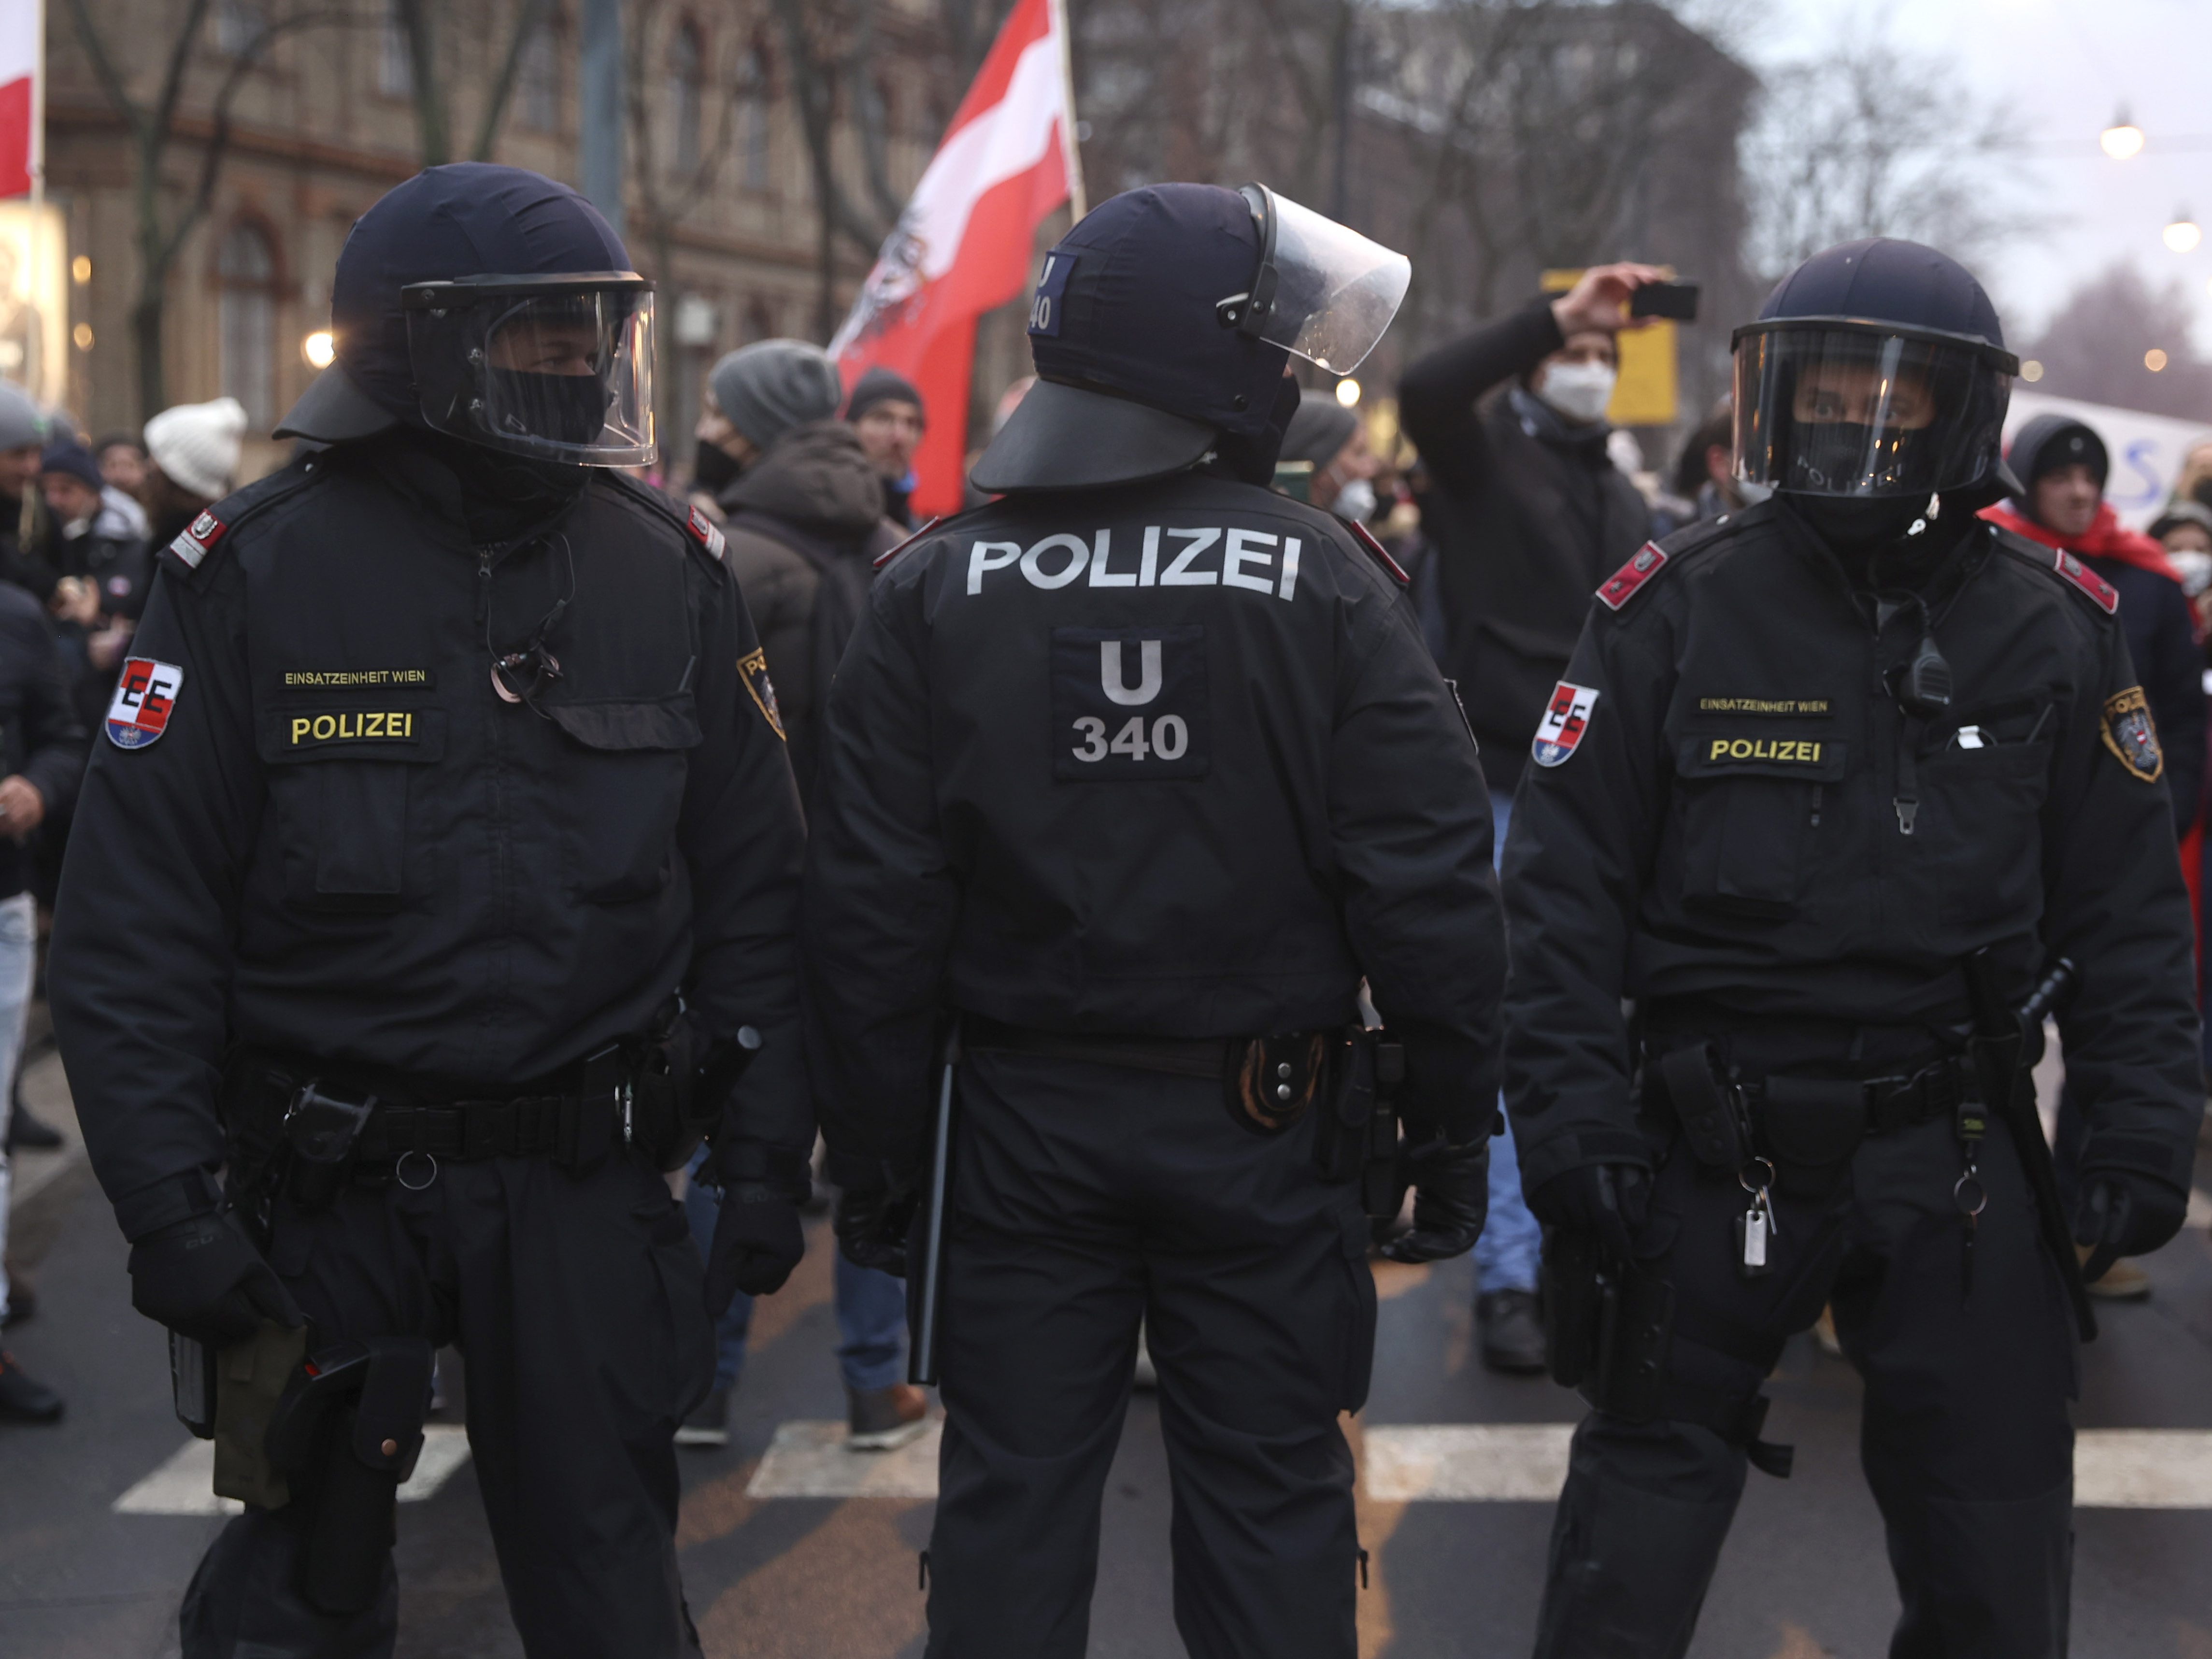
[803,473,1504,1168]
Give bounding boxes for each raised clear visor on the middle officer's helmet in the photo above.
[1243,184,1413,374]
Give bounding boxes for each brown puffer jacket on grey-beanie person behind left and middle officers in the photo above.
[721,420,907,801]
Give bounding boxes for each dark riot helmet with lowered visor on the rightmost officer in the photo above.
[1734,237,2020,500]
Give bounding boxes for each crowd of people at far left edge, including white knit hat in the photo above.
[0,381,248,1422]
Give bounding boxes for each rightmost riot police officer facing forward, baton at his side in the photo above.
[1504,241,2203,1659]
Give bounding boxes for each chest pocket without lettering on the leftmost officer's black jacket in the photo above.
[546,692,703,905]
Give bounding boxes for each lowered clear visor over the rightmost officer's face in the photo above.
[1737,321,2011,498]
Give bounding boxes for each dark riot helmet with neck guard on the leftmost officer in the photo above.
[276,161,655,467]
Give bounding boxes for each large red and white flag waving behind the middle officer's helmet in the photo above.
[831,0,1082,515]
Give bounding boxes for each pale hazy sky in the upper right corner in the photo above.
[1716,0,2212,349]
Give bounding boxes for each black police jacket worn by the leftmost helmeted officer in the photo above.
[53,443,814,1239]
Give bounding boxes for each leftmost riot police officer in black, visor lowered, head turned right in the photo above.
[53,164,812,1659]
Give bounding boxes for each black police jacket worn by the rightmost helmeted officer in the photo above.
[1504,502,2203,1190]
